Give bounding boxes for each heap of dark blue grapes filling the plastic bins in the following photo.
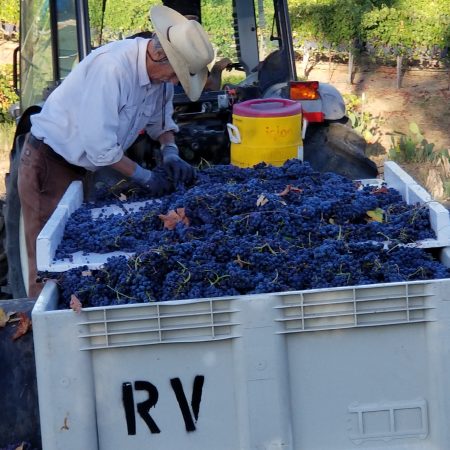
[45,160,449,308]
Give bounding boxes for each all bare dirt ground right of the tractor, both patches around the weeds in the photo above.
[299,59,450,200]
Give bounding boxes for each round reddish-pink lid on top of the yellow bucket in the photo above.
[233,98,302,117]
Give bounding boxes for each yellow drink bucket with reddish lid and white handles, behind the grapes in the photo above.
[227,98,303,167]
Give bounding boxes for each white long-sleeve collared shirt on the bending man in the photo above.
[31,38,178,170]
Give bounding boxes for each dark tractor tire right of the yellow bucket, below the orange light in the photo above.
[303,123,378,180]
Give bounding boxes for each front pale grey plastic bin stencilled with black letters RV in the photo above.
[33,280,450,450]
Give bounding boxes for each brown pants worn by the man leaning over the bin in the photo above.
[18,134,86,297]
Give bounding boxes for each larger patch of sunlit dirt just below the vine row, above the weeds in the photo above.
[308,59,450,150]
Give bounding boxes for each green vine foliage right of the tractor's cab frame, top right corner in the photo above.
[289,0,450,60]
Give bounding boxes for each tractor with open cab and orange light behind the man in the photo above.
[3,0,377,298]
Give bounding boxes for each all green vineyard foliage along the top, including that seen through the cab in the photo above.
[0,0,450,61]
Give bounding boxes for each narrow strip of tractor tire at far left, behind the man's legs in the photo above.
[3,136,28,298]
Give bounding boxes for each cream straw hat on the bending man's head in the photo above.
[150,5,214,101]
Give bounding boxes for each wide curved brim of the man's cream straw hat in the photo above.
[150,6,208,101]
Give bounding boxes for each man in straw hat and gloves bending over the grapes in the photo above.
[18,6,214,297]
